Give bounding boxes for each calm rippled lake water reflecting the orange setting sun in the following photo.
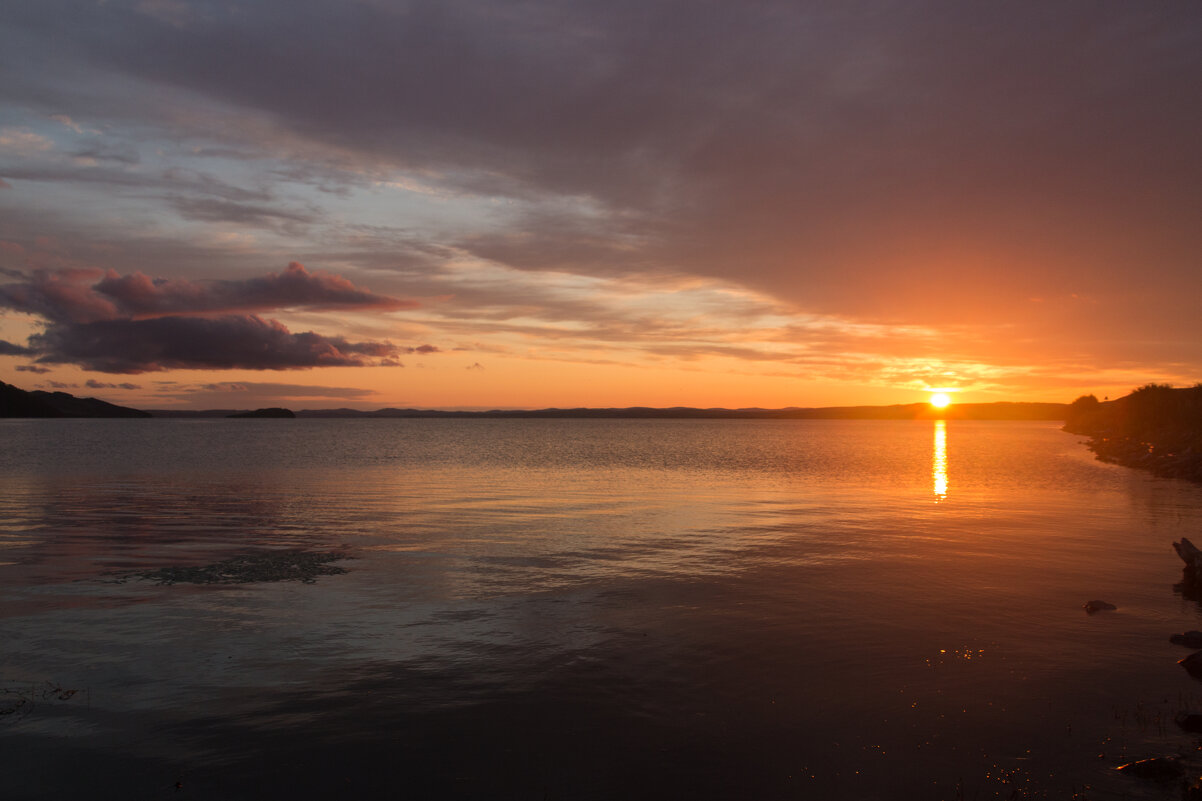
[0,420,1202,800]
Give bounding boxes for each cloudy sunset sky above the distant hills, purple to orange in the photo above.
[0,0,1202,409]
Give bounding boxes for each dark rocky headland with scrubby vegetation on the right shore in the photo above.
[1064,384,1202,482]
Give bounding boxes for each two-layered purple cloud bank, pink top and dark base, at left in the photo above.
[0,262,420,373]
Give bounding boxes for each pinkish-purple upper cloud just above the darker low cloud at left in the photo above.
[0,262,417,324]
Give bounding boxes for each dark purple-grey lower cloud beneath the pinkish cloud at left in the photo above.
[30,315,397,373]
